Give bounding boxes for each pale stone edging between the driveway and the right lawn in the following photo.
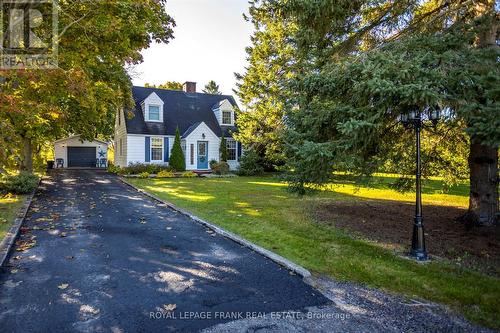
[118,177,311,278]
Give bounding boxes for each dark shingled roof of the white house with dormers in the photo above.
[125,87,237,136]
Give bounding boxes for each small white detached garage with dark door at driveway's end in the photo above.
[54,135,108,168]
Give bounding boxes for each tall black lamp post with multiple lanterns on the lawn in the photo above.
[401,106,440,261]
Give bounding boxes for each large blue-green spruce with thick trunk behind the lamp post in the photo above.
[280,0,500,224]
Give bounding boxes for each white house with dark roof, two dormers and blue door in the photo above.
[114,82,241,171]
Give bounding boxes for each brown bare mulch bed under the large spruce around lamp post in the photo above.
[315,200,500,277]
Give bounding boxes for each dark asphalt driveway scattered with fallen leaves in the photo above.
[0,170,329,332]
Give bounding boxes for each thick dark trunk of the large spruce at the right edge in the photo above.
[467,142,499,225]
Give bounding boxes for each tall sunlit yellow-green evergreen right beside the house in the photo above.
[235,1,297,169]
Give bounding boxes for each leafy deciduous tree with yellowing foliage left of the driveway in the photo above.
[0,0,174,170]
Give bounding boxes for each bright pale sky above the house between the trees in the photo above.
[130,0,253,94]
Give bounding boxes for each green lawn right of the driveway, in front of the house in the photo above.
[128,176,500,329]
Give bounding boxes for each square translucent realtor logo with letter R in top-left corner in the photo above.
[0,0,58,69]
